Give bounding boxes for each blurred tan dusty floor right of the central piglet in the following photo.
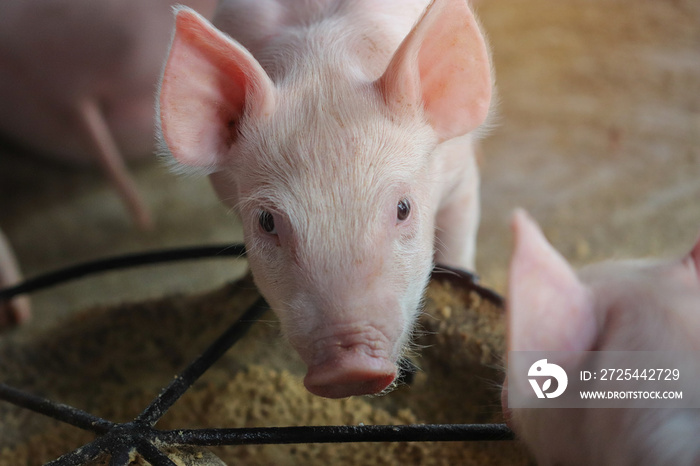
[477,0,700,288]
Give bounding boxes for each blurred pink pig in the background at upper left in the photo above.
[0,0,216,324]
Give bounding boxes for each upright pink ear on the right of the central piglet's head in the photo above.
[377,0,492,140]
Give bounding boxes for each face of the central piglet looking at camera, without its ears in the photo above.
[229,89,435,398]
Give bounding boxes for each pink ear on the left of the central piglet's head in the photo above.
[157,7,275,170]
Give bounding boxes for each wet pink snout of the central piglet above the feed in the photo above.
[304,329,396,398]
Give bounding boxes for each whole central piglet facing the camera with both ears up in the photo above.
[158,0,492,398]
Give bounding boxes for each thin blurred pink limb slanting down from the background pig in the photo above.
[78,99,152,230]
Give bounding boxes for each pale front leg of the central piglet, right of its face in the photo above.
[435,149,479,271]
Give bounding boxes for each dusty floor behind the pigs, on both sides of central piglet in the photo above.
[0,0,700,462]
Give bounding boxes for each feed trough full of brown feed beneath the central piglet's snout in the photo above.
[0,247,528,465]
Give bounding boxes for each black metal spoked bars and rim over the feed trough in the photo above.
[0,244,514,466]
